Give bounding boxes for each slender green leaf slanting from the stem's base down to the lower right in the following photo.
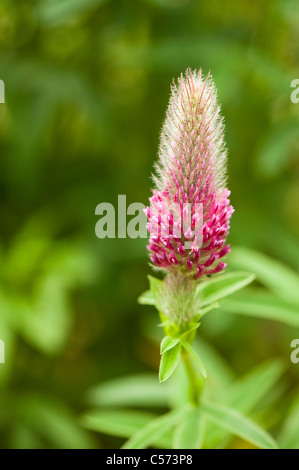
[200,403,278,449]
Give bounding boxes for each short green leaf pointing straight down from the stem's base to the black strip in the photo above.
[173,408,206,449]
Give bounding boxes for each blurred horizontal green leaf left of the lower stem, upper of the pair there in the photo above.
[87,374,170,407]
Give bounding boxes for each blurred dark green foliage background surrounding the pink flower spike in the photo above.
[0,0,299,448]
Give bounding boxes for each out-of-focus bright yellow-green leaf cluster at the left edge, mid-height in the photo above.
[0,241,94,355]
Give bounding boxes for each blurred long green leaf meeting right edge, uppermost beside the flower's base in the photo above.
[230,247,299,305]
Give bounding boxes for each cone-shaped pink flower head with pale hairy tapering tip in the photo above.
[146,69,234,278]
